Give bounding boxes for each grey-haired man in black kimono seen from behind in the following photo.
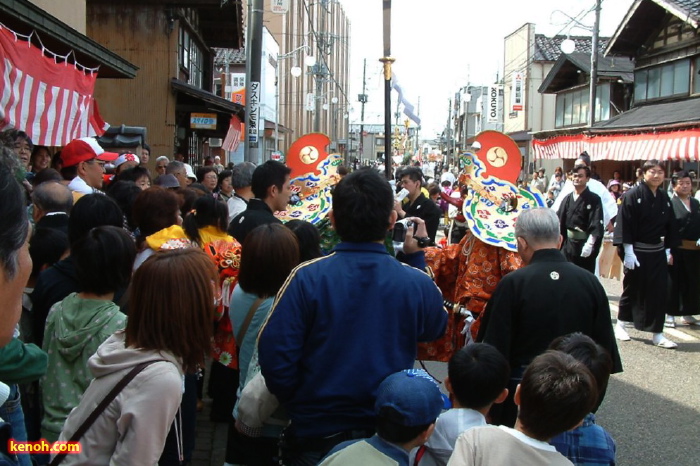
[477,208,622,427]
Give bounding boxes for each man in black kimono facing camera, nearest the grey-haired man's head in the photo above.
[557,165,603,273]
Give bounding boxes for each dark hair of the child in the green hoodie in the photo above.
[71,226,136,295]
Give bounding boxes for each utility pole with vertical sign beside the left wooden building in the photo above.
[244,0,264,164]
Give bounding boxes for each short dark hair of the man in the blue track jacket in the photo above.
[333,168,394,243]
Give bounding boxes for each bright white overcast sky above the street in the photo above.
[340,0,633,138]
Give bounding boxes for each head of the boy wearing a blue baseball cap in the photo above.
[374,369,444,446]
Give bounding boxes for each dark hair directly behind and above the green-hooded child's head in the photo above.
[68,193,124,248]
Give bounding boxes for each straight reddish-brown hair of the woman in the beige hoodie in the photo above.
[126,248,219,373]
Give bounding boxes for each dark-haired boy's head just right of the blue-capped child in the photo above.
[445,343,510,411]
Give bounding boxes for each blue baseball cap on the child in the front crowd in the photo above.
[374,369,444,427]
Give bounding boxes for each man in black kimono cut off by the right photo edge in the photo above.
[666,171,700,327]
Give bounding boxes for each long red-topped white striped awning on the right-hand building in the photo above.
[532,128,700,162]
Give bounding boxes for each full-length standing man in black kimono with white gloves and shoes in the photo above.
[613,160,678,349]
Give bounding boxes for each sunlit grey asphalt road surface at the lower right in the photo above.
[416,279,700,466]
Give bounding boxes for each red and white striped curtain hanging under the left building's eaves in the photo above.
[0,26,107,146]
